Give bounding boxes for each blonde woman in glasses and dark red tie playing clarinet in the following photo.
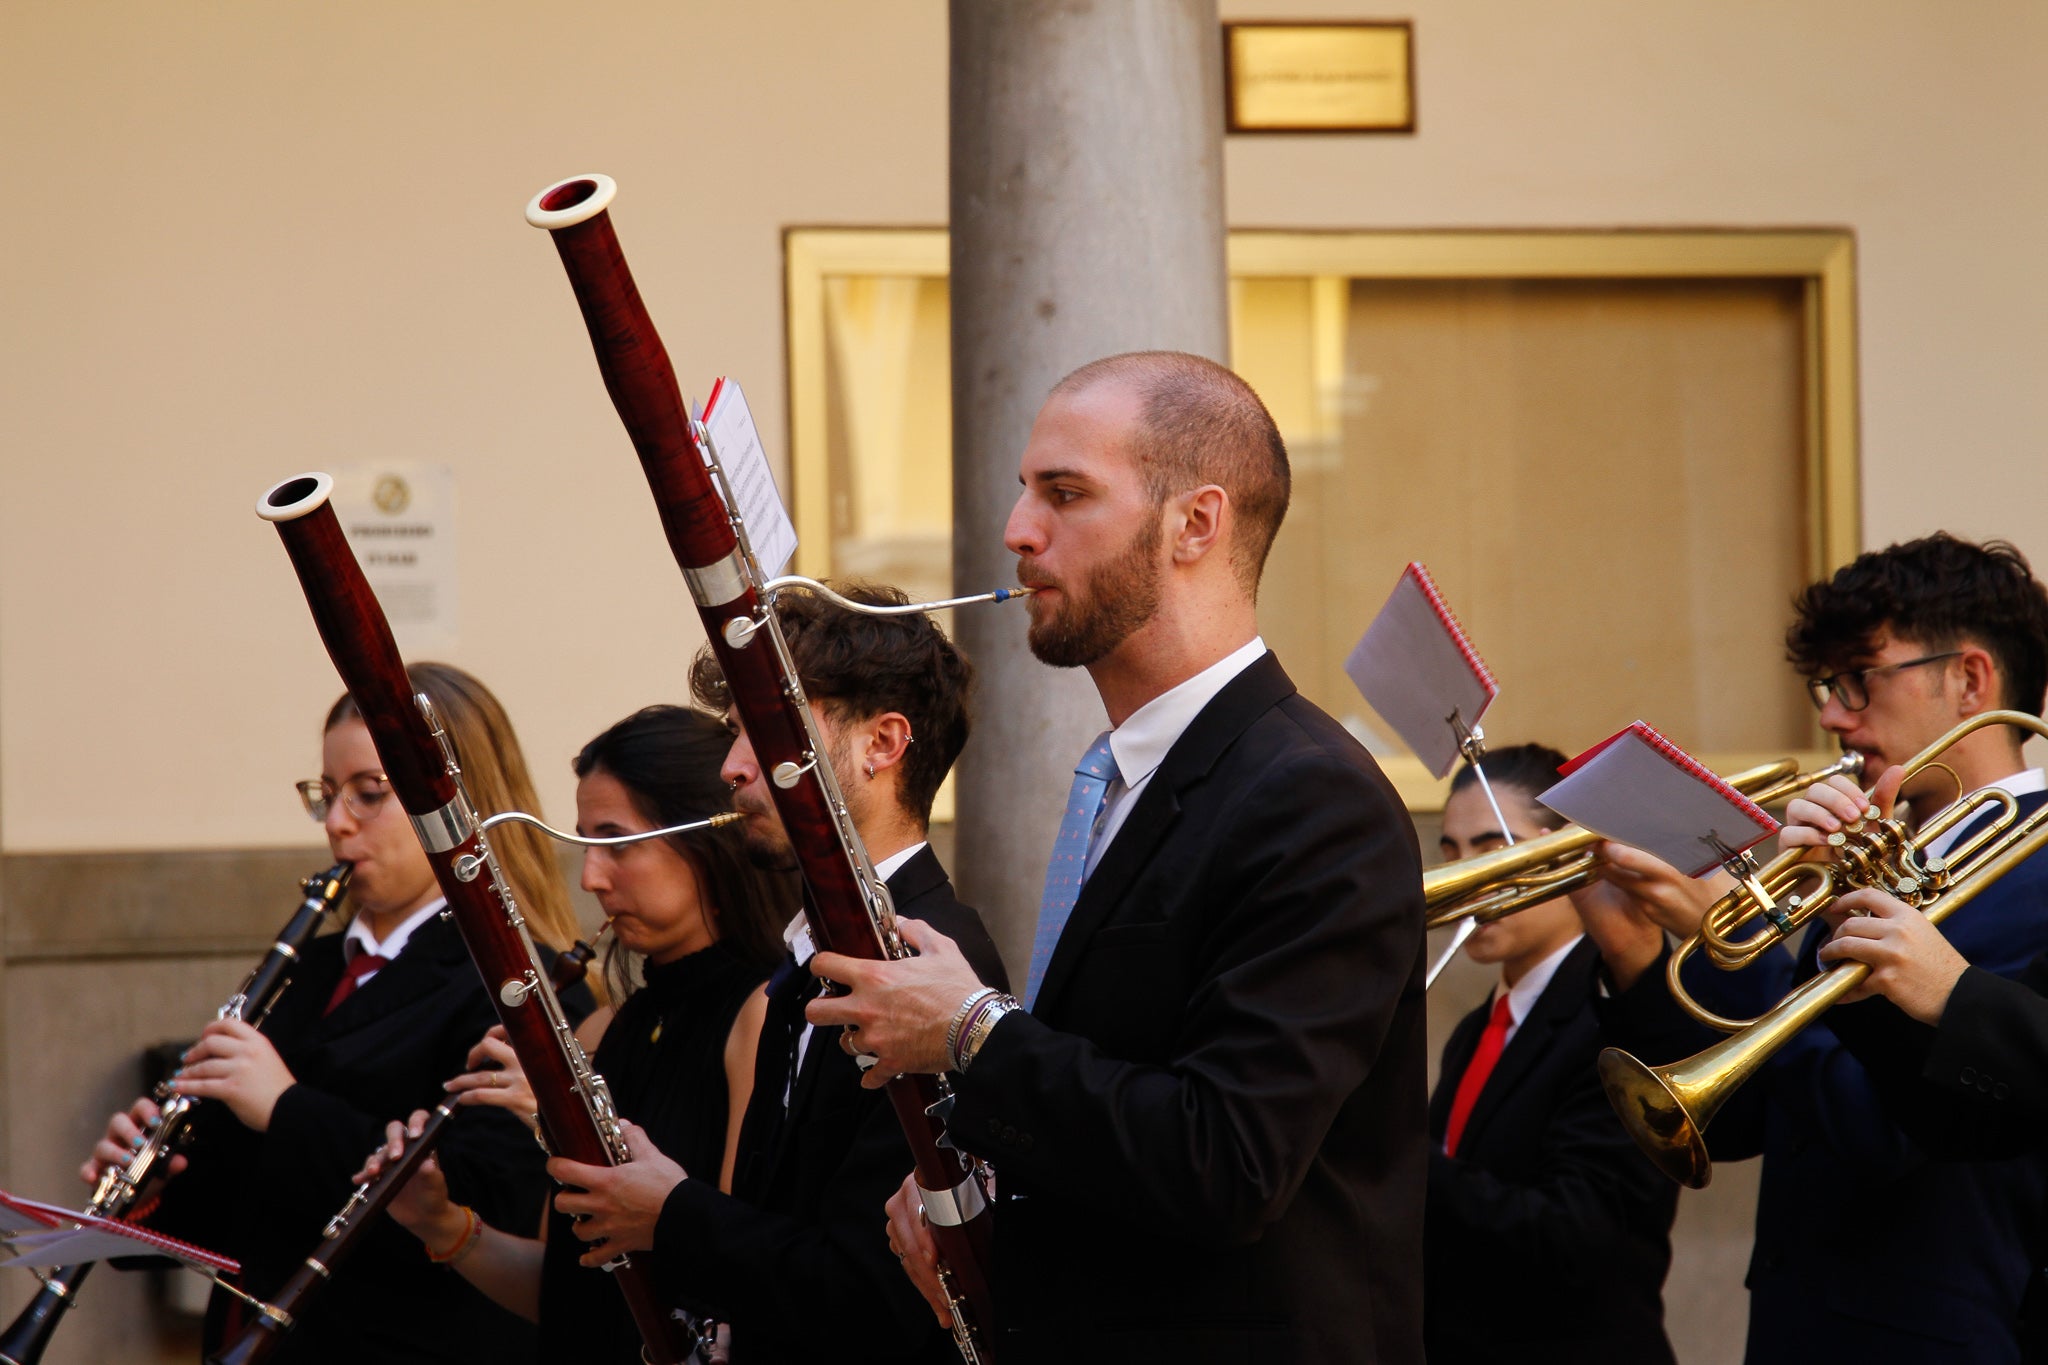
[82,663,594,1365]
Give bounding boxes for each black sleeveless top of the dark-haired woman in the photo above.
[541,939,762,1365]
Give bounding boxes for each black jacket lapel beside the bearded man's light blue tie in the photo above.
[1032,651,1294,1015]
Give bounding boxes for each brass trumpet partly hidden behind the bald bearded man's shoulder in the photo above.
[1421,753,1864,929]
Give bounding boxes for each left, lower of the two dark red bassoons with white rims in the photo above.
[256,475,694,1365]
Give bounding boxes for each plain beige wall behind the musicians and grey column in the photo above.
[0,0,2048,1359]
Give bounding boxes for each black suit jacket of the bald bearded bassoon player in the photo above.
[952,655,1427,1365]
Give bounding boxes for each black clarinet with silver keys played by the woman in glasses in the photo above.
[0,864,352,1365]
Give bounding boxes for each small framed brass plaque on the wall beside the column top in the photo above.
[1223,20,1415,133]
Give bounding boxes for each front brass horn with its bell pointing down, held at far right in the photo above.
[1599,710,2048,1189]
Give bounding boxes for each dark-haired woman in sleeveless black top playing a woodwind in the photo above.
[367,706,795,1361]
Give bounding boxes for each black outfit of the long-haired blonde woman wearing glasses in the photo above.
[147,915,592,1365]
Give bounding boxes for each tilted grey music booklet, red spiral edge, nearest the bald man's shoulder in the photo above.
[1343,565,1501,778]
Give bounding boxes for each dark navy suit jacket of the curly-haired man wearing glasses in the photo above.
[1604,794,2048,1365]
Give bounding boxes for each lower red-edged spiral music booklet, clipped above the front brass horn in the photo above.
[1542,720,1778,876]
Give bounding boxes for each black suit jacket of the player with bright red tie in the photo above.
[1423,939,1677,1365]
